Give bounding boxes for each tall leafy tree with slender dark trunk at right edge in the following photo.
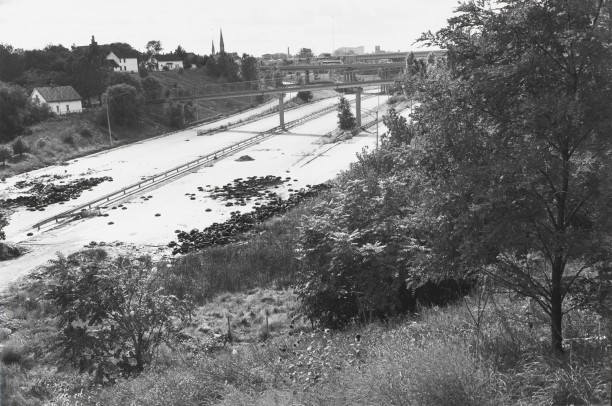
[415,0,612,352]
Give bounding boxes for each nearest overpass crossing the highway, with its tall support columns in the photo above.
[145,78,399,128]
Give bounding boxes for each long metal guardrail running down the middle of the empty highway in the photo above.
[32,99,366,230]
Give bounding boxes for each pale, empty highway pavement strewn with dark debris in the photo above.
[0,96,394,287]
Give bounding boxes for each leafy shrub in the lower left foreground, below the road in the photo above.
[46,250,191,383]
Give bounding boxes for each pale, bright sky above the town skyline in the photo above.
[0,0,458,56]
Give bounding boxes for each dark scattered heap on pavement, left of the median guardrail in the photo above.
[0,176,113,211]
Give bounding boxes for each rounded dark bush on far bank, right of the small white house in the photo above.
[104,84,143,127]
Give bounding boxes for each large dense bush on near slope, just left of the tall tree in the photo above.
[297,147,470,327]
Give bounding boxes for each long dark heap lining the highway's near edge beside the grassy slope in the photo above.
[168,183,331,255]
